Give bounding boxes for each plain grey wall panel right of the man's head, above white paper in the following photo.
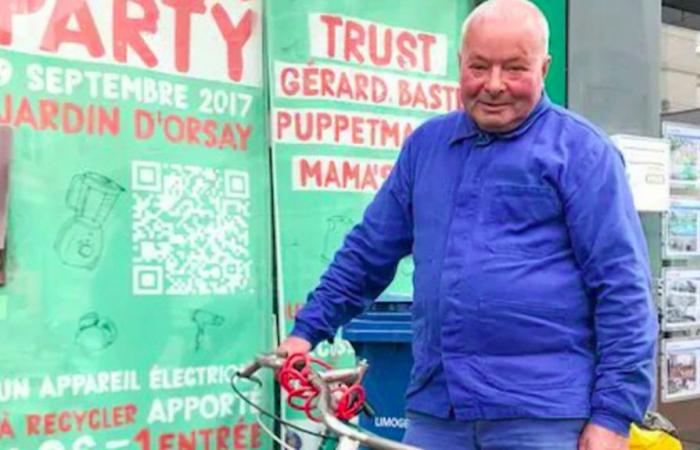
[568,0,661,136]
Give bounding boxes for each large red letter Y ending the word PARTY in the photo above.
[211,7,255,81]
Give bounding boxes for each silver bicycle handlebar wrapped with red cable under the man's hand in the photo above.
[238,354,421,450]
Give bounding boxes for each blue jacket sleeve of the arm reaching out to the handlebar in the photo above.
[291,137,413,346]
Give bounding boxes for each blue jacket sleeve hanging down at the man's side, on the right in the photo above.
[565,139,658,435]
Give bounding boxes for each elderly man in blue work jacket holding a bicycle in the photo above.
[280,0,656,450]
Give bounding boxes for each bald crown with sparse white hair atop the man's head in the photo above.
[461,0,549,56]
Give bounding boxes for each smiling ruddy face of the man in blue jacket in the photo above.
[459,18,550,133]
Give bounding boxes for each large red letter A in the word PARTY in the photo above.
[41,0,105,58]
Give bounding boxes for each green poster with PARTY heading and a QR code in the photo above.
[0,0,273,450]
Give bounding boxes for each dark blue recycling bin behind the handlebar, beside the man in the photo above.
[343,298,413,441]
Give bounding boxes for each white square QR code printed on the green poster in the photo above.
[131,161,252,295]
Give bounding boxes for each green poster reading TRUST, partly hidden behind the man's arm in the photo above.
[266,0,467,449]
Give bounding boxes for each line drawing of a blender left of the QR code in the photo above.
[54,172,124,270]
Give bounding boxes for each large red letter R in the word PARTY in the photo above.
[112,0,159,67]
